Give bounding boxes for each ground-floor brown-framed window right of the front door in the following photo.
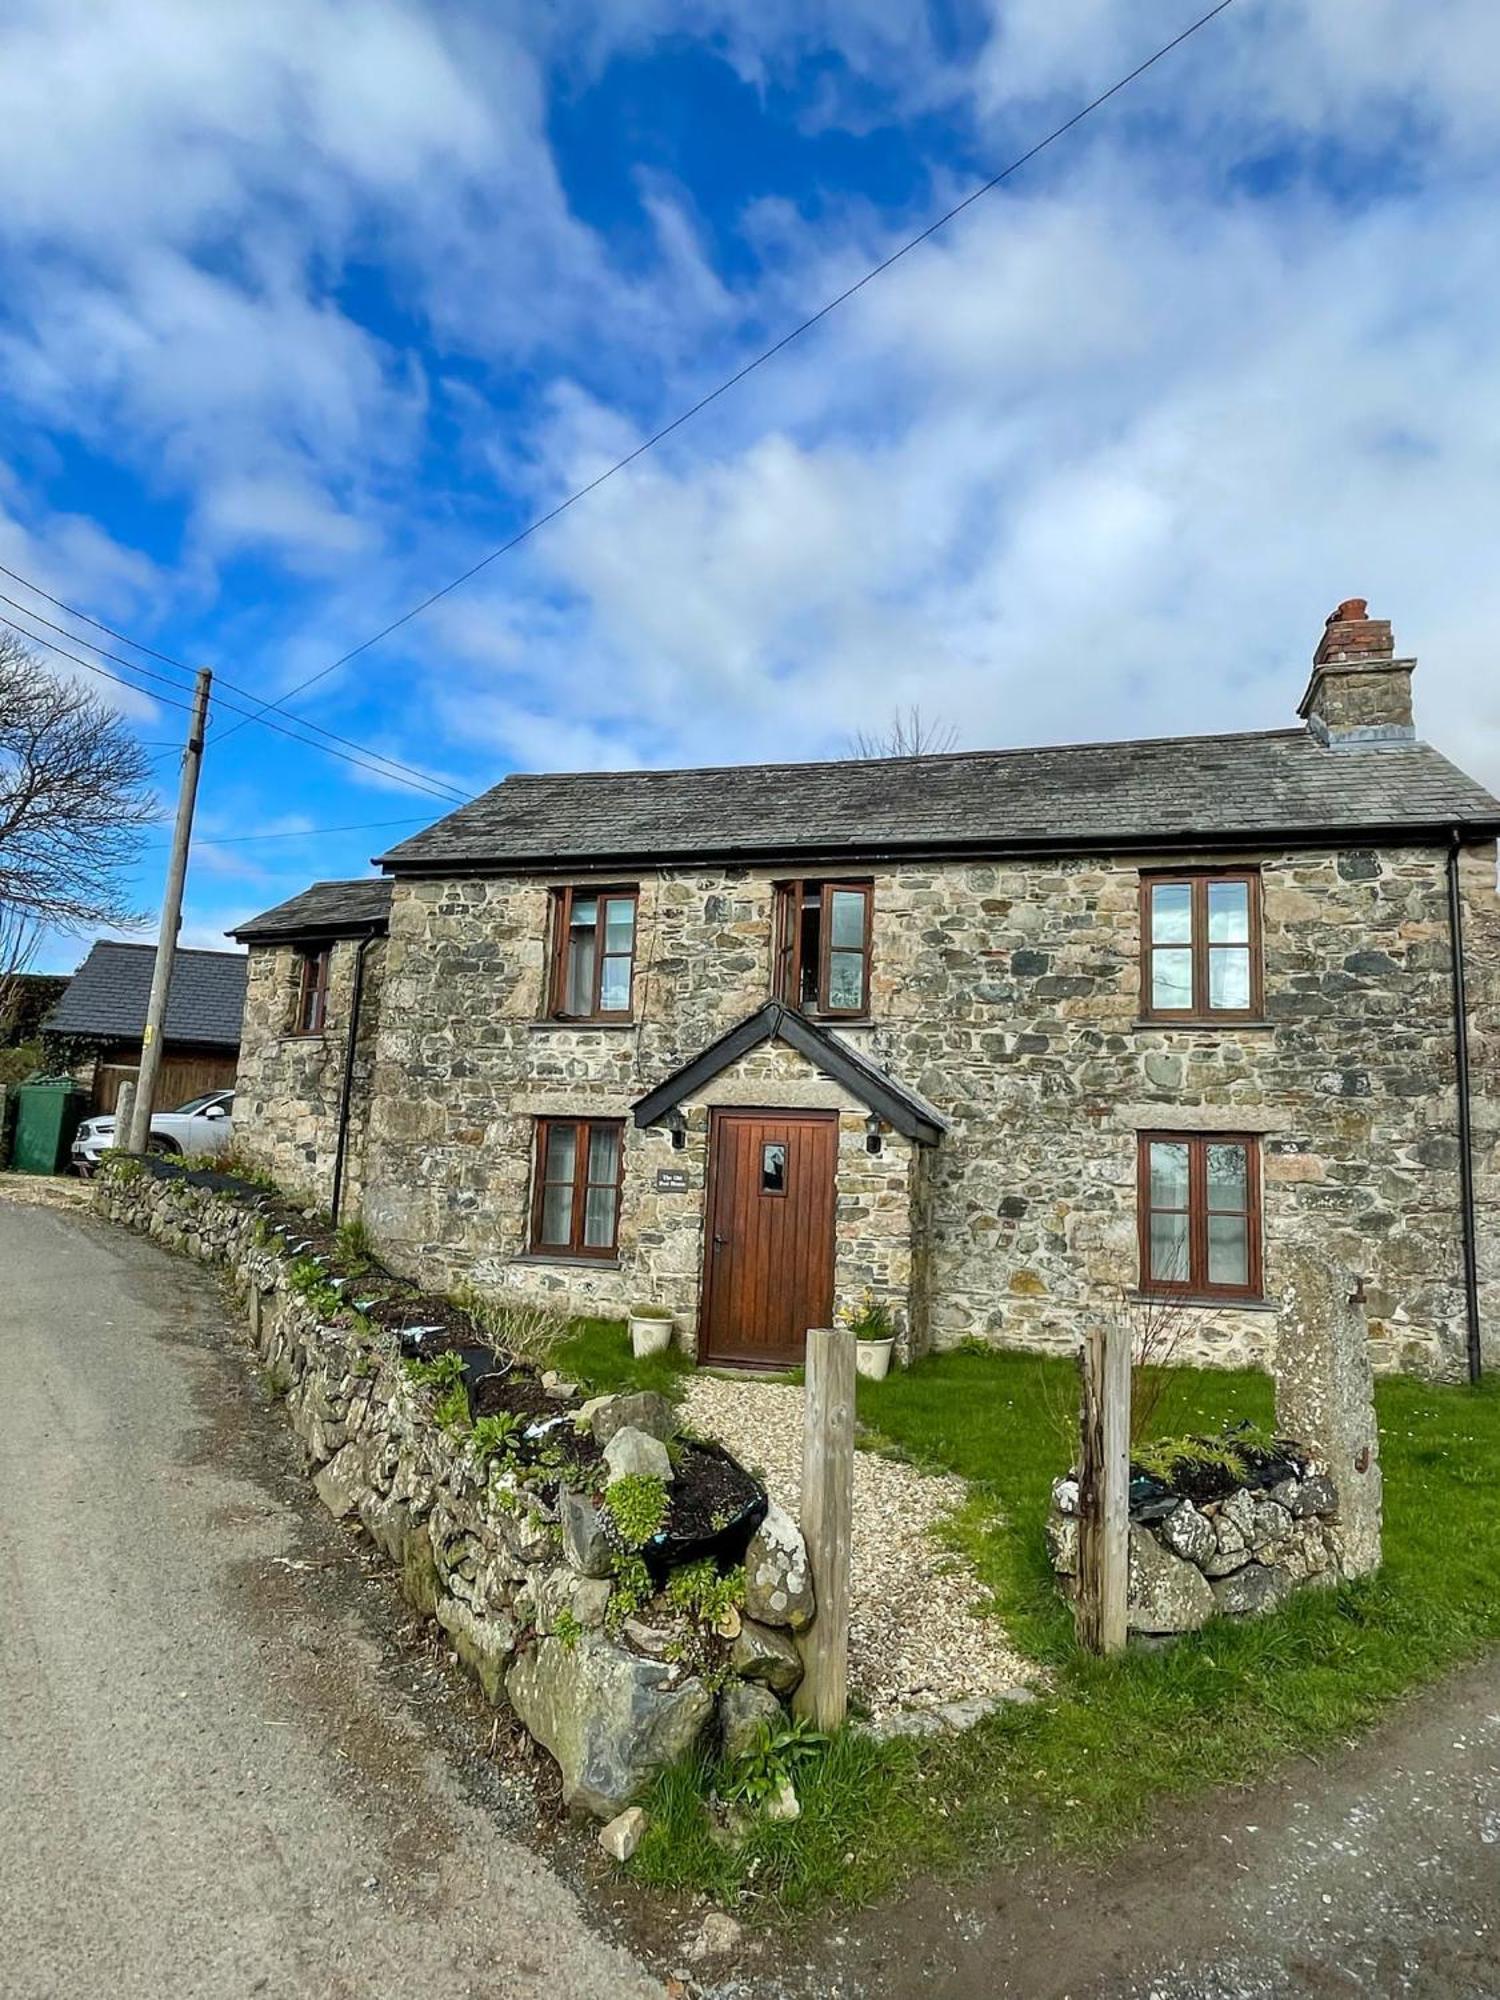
[1140,1132,1262,1300]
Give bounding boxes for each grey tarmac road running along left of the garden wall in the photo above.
[0,1198,662,2000]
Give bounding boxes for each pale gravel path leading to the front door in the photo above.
[682,1374,1036,1718]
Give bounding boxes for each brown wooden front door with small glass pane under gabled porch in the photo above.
[698,1110,838,1368]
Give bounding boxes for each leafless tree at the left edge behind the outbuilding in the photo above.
[0,634,156,1014]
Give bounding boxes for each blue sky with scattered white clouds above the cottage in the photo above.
[0,0,1500,968]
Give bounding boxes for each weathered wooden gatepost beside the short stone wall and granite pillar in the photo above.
[1076,1324,1130,1652]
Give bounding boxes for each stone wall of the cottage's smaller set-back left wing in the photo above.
[234,938,386,1214]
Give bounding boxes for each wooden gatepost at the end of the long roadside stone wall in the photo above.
[792,1326,854,1730]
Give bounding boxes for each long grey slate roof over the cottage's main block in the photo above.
[380,730,1500,874]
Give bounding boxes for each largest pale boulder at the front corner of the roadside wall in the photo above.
[506,1632,714,1820]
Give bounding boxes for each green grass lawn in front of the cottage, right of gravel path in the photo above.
[636,1352,1500,1910]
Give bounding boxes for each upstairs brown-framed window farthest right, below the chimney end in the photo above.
[1140,874,1262,1020]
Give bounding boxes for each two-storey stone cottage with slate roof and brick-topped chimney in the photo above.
[226,602,1500,1374]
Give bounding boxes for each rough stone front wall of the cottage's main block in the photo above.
[356,846,1500,1372]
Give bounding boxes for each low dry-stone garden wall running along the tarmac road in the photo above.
[96,1164,816,1818]
